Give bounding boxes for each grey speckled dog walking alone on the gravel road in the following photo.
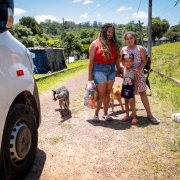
[52,86,70,117]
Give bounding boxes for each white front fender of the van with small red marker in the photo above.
[0,31,34,106]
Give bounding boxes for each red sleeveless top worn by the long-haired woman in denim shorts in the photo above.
[94,39,116,64]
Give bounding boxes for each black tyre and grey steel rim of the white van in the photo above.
[2,104,38,179]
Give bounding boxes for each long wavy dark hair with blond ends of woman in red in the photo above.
[99,23,120,60]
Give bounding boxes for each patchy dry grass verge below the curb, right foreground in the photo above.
[129,69,180,180]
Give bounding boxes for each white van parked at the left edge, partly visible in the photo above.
[0,0,41,180]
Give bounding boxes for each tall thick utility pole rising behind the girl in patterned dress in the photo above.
[148,0,152,59]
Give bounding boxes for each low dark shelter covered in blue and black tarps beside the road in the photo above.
[28,47,67,74]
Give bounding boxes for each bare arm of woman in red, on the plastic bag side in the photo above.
[88,41,96,81]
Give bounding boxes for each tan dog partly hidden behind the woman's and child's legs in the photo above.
[110,85,125,112]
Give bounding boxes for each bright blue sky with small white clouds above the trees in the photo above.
[14,0,180,26]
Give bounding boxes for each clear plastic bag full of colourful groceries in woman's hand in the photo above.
[84,81,98,109]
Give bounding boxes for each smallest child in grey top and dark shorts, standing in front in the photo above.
[121,54,138,125]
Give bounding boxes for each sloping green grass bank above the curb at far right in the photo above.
[152,42,180,80]
